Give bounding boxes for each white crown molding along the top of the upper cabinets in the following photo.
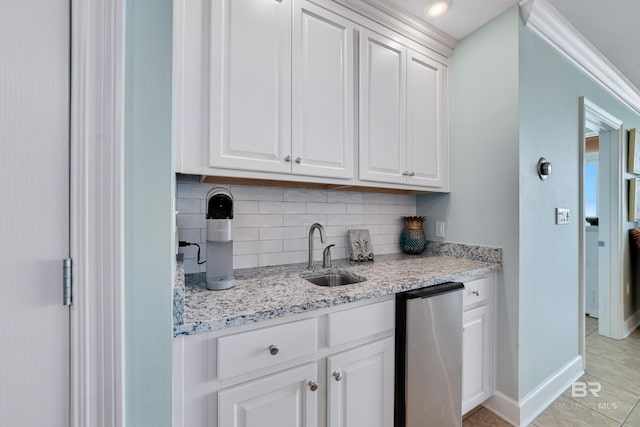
[328,0,458,57]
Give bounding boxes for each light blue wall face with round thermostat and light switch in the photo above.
[519,14,640,398]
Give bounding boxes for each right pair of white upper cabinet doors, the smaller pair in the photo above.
[359,30,448,188]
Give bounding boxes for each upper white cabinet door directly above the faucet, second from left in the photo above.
[292,1,355,178]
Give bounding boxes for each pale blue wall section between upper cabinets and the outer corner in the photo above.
[417,8,519,399]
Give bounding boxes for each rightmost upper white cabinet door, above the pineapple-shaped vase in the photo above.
[407,50,449,187]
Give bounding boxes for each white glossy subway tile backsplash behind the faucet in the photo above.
[176,176,416,274]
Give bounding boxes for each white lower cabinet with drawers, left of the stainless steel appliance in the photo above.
[174,296,395,427]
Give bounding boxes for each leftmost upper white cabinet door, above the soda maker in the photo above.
[209,0,292,172]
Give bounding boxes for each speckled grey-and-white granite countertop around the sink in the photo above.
[173,245,502,336]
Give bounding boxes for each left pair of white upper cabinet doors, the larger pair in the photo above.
[208,0,355,178]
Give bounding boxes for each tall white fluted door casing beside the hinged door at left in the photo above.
[70,0,125,427]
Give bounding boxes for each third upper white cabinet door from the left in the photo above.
[359,29,407,184]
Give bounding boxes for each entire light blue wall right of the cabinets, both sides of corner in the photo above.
[417,7,640,400]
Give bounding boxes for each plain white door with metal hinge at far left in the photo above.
[0,0,70,427]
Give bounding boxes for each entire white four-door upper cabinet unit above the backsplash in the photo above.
[173,0,450,191]
